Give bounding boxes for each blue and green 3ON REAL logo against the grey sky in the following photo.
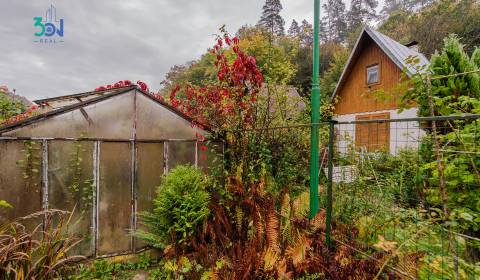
[33,5,64,44]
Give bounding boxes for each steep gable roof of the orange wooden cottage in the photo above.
[331,26,430,99]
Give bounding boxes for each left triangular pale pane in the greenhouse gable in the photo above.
[3,91,134,140]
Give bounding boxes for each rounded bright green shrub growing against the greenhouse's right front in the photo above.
[135,166,210,248]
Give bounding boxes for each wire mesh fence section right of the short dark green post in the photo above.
[320,114,480,279]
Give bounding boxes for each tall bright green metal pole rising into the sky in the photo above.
[310,0,320,219]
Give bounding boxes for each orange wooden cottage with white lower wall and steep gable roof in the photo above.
[331,27,429,154]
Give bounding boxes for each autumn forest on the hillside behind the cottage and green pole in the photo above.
[160,0,480,106]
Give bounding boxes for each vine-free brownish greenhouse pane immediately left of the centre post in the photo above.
[97,142,132,255]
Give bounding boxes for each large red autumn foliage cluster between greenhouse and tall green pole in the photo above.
[170,34,263,129]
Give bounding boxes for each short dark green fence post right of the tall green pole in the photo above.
[325,120,336,247]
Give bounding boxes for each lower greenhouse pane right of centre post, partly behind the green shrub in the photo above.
[135,143,164,249]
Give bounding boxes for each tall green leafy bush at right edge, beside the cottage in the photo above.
[403,35,480,233]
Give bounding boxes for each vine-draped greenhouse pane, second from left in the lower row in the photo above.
[48,141,95,256]
